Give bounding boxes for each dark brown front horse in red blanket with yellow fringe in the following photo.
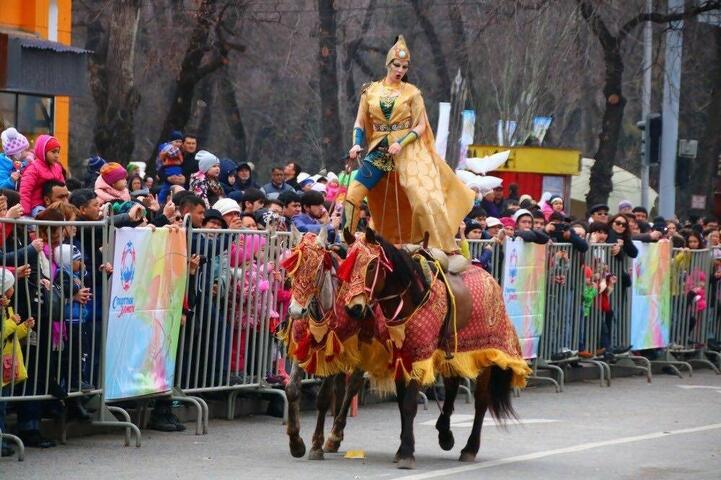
[338,228,530,469]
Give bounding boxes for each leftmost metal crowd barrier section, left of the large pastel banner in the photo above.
[0,218,141,460]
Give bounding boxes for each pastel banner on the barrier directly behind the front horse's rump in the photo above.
[503,238,546,359]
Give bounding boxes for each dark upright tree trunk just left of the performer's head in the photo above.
[318,0,343,170]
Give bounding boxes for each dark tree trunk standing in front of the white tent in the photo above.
[586,41,626,206]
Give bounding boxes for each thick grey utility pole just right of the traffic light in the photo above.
[658,0,684,218]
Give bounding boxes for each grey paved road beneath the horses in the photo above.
[0,370,721,480]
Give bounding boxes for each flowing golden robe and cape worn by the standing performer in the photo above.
[360,81,475,252]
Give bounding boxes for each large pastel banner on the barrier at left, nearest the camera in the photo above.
[105,228,187,400]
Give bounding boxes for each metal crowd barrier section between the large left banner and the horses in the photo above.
[176,224,289,419]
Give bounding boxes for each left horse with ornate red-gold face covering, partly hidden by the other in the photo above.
[281,226,363,460]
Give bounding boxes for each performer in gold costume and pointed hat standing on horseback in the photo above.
[345,35,474,253]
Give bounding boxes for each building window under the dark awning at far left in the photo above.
[0,91,55,140]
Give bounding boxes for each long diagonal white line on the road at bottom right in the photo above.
[393,423,721,480]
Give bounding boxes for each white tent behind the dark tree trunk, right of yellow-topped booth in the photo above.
[571,158,658,214]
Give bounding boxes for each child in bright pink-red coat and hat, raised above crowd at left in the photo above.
[20,135,65,216]
